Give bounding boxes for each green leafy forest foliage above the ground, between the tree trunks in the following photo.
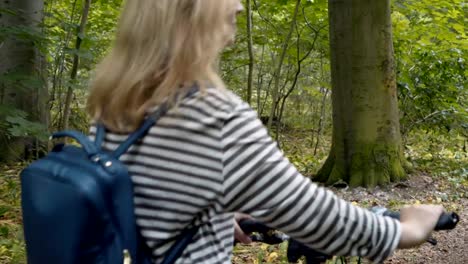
[0,0,468,159]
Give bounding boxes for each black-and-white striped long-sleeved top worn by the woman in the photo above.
[91,88,401,264]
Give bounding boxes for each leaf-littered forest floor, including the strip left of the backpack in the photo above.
[0,147,468,264]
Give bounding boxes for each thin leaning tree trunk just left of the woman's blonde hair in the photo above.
[61,0,91,130]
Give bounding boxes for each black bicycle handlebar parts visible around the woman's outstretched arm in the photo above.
[239,207,460,264]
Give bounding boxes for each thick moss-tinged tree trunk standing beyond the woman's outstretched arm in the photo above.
[316,0,406,186]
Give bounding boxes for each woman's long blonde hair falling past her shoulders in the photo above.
[88,0,236,132]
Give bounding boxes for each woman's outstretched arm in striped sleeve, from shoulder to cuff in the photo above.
[222,104,438,262]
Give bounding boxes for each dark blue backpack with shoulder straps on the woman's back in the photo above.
[20,94,198,264]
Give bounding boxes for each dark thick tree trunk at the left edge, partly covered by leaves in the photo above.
[0,0,48,162]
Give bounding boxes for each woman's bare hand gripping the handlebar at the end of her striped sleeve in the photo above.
[398,205,444,248]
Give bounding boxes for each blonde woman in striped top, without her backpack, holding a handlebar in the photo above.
[88,0,442,264]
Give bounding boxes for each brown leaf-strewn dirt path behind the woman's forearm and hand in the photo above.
[233,173,468,264]
